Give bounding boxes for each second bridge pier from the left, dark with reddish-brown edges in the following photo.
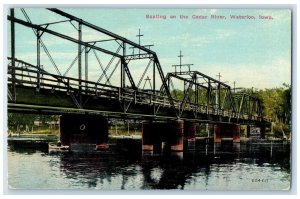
[142,120,184,151]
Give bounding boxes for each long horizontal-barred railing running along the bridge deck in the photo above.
[8,60,261,120]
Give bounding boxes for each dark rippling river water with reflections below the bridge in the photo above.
[7,139,291,190]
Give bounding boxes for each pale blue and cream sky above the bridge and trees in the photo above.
[8,8,291,89]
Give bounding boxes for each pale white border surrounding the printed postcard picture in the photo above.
[0,0,300,198]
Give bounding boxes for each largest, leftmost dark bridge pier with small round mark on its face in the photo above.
[60,114,108,151]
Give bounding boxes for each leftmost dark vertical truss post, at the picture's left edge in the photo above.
[10,8,16,101]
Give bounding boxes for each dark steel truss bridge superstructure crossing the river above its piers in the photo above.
[7,8,264,123]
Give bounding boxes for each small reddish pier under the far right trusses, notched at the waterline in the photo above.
[214,124,241,143]
